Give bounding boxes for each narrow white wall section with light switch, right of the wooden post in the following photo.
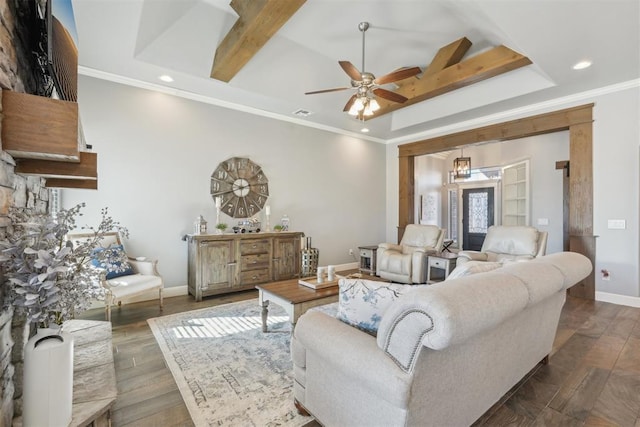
[593,88,640,297]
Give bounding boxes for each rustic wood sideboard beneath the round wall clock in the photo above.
[187,231,304,301]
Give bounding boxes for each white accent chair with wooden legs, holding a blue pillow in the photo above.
[67,231,164,321]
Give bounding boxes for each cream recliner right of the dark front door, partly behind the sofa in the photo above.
[456,225,548,266]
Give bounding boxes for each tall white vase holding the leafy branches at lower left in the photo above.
[22,328,73,427]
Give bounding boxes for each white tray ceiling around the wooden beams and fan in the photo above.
[73,0,640,142]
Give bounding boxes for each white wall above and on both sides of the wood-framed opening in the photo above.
[386,81,640,298]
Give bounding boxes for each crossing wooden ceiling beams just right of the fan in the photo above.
[365,42,532,119]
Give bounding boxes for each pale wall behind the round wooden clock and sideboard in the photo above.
[62,76,385,287]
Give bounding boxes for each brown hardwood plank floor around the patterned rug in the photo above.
[81,291,640,427]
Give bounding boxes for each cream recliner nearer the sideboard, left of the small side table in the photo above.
[376,224,446,284]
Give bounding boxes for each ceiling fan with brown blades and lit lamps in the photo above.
[305,22,422,119]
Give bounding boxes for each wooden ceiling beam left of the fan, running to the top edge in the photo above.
[211,0,306,82]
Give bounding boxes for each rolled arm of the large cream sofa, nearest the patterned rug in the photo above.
[294,310,411,407]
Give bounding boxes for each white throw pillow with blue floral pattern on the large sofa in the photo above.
[336,279,425,336]
